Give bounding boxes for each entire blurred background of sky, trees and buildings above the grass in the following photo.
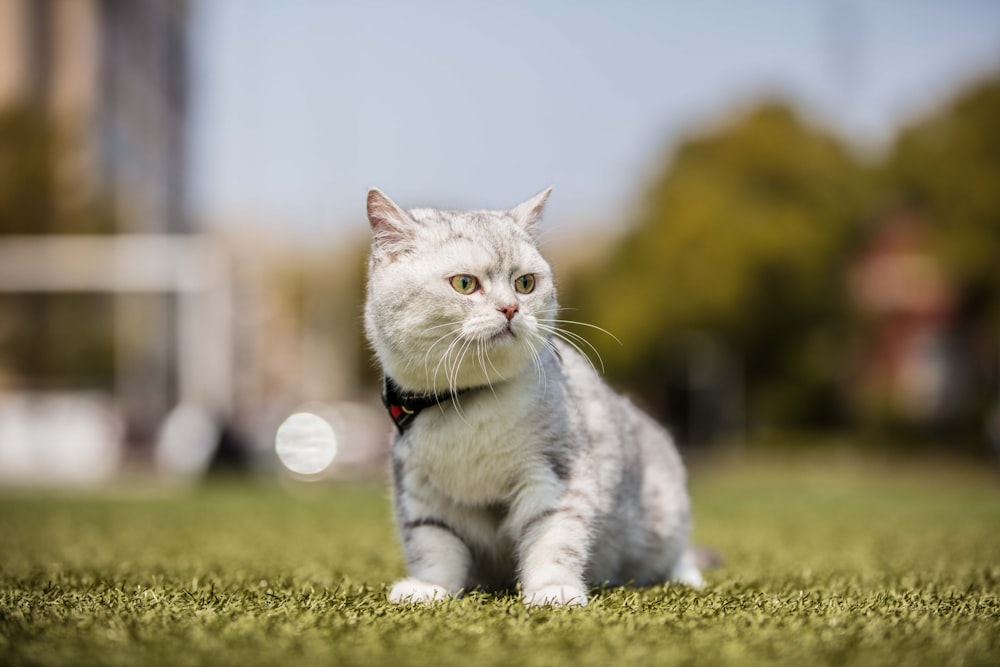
[0,0,1000,484]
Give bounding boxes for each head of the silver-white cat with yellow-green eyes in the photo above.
[365,188,557,392]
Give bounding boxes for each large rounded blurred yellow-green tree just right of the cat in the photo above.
[565,104,865,438]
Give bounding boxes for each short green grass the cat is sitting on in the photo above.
[0,452,1000,667]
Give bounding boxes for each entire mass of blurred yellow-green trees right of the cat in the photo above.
[564,76,1000,433]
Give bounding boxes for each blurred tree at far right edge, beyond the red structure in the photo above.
[880,73,1000,432]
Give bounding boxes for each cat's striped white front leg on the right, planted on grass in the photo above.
[517,491,591,606]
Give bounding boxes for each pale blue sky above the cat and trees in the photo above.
[189,0,1000,238]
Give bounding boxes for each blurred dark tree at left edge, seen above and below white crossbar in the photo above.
[0,106,115,388]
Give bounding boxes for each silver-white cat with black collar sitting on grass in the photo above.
[364,188,703,605]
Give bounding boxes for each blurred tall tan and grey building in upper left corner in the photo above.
[0,0,189,233]
